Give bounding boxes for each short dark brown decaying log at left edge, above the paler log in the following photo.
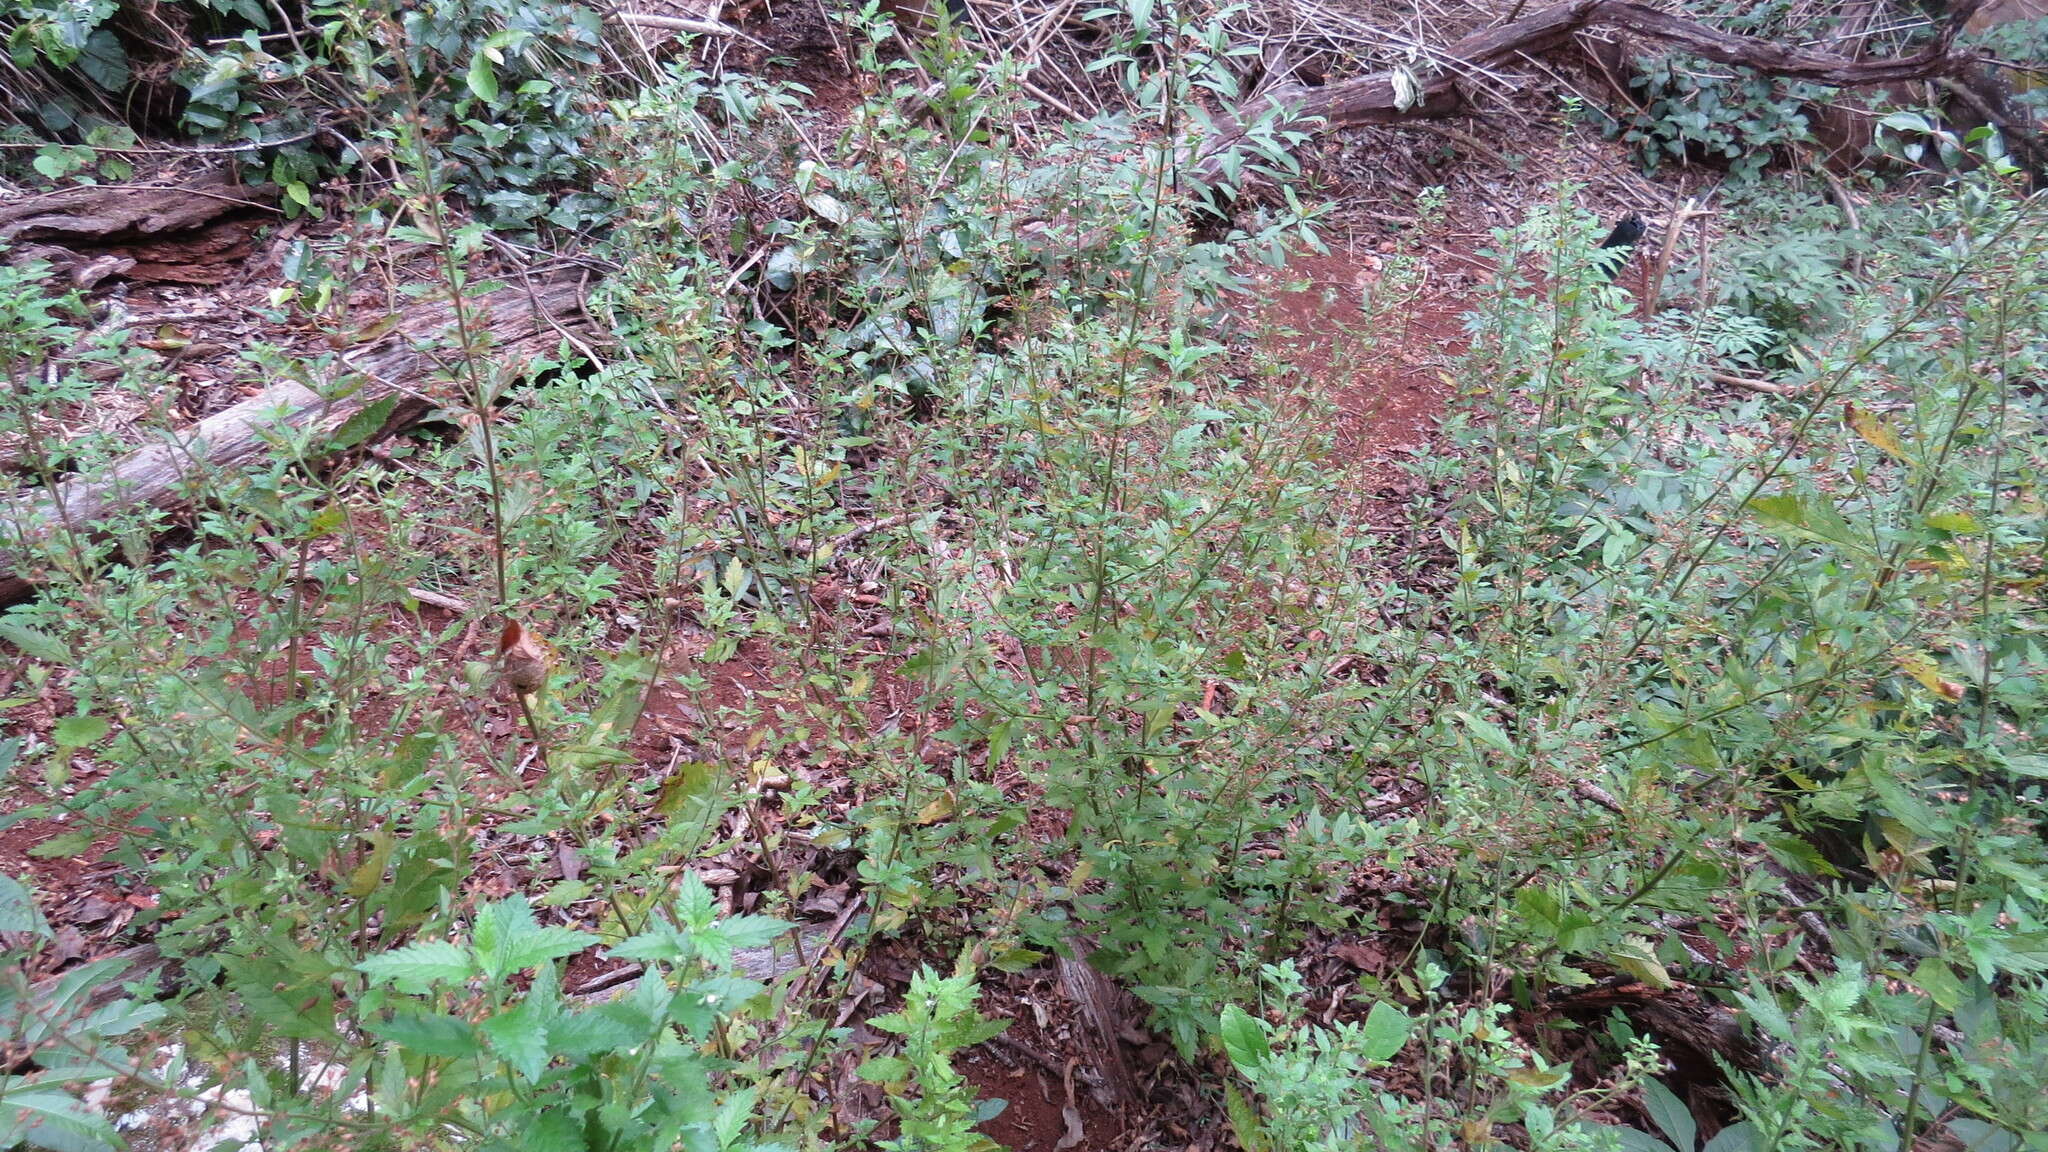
[0,168,276,244]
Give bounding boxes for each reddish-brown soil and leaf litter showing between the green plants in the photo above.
[0,8,1728,1152]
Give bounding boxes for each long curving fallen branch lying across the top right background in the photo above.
[1194,0,1980,180]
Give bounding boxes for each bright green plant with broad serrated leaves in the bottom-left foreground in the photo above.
[338,877,788,1152]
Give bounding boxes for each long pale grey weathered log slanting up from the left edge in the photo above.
[0,277,584,605]
